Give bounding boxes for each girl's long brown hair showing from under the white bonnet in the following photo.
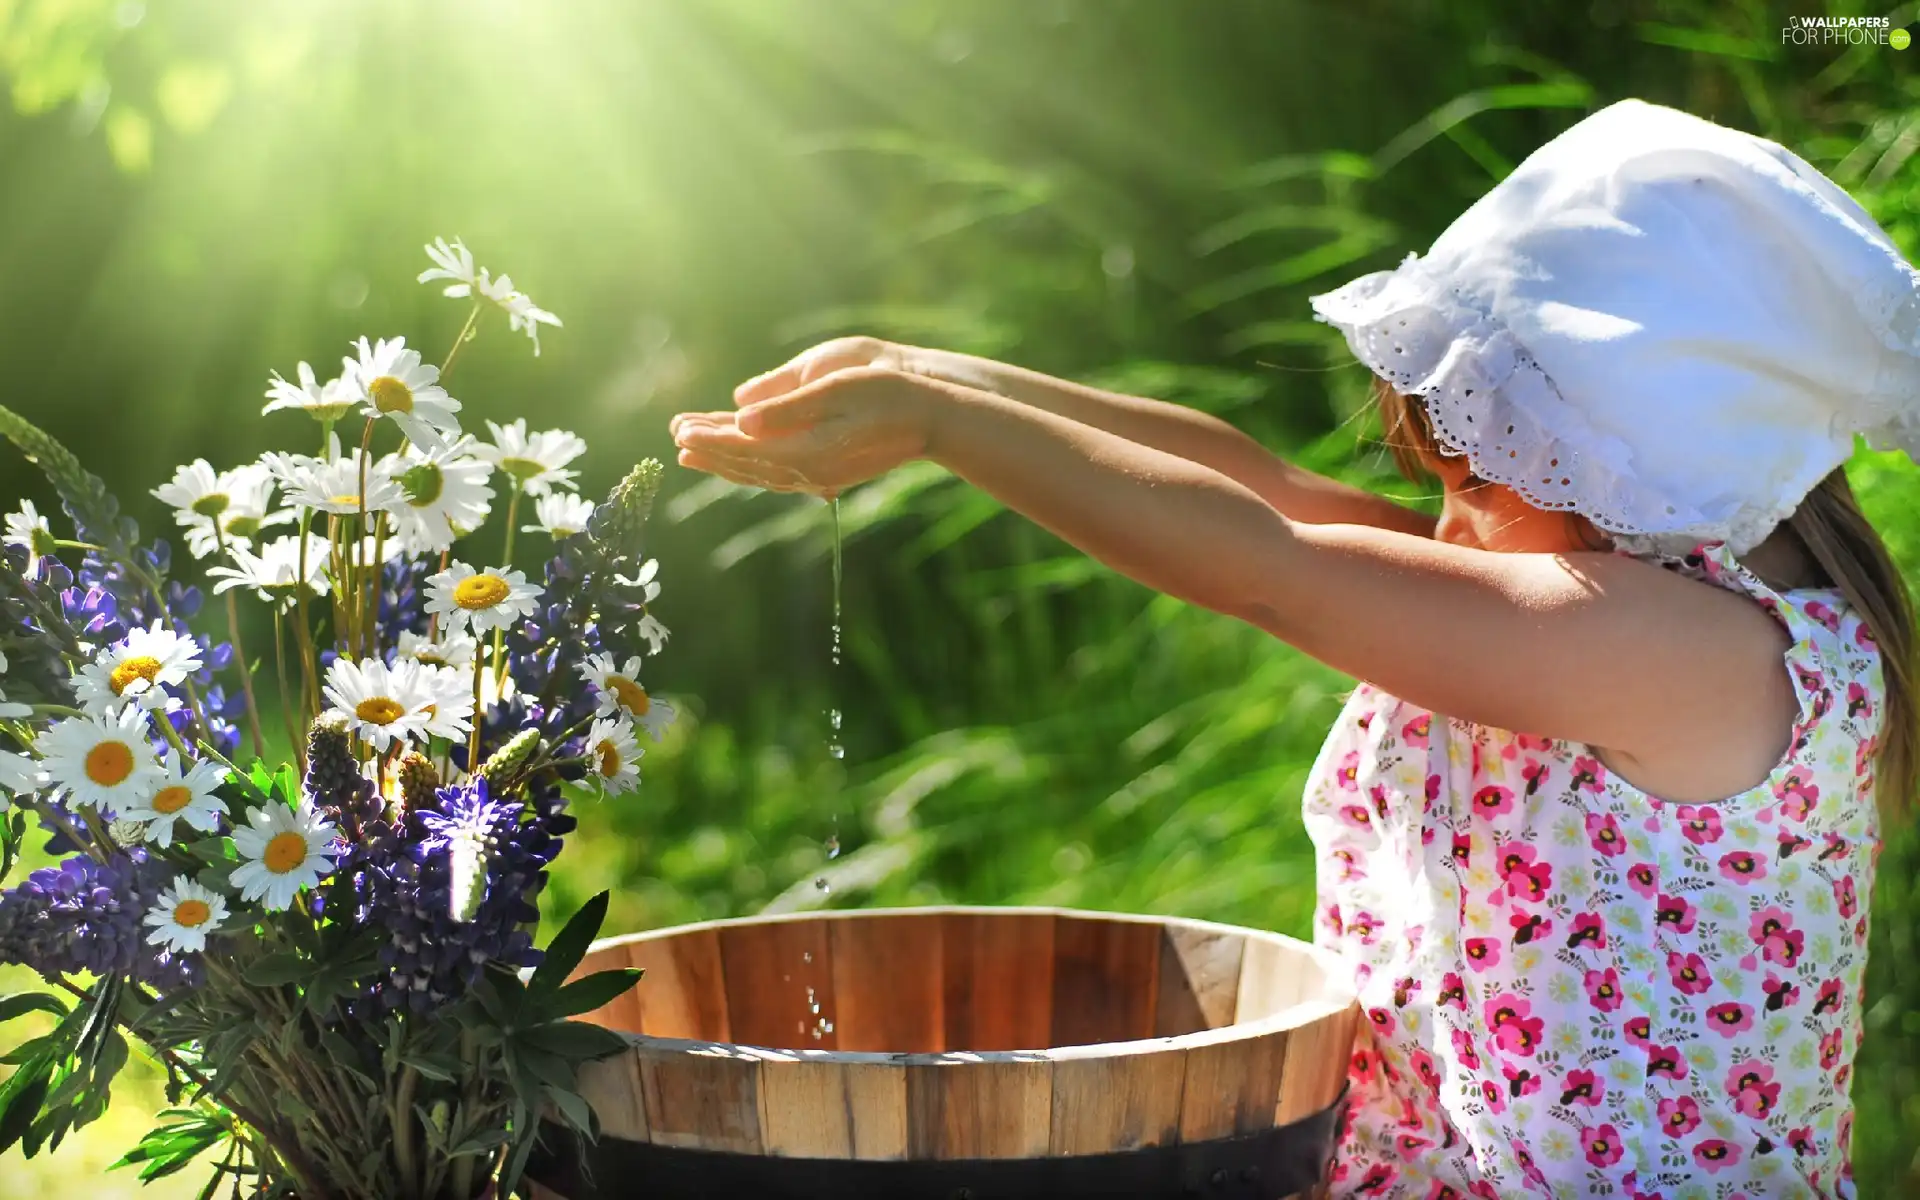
[1375,378,1920,828]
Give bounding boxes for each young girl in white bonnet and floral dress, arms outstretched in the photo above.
[674,102,1920,1200]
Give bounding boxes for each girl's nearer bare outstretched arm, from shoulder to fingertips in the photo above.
[676,369,1795,801]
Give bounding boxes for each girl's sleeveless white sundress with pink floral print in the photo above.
[1306,543,1882,1200]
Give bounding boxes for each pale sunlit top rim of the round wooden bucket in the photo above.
[582,904,1359,1068]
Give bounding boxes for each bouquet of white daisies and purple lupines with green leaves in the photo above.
[0,242,672,1200]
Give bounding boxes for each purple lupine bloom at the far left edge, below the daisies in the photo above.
[0,849,200,991]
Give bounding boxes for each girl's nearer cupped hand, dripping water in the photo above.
[672,362,943,495]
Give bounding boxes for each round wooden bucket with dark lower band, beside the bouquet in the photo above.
[528,908,1359,1200]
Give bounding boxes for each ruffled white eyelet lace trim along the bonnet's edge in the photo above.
[1313,253,1920,555]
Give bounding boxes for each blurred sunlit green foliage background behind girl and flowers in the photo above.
[0,0,1920,1196]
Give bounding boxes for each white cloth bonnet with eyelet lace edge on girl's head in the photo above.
[1311,100,1920,555]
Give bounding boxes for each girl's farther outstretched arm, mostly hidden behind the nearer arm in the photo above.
[733,338,1434,536]
